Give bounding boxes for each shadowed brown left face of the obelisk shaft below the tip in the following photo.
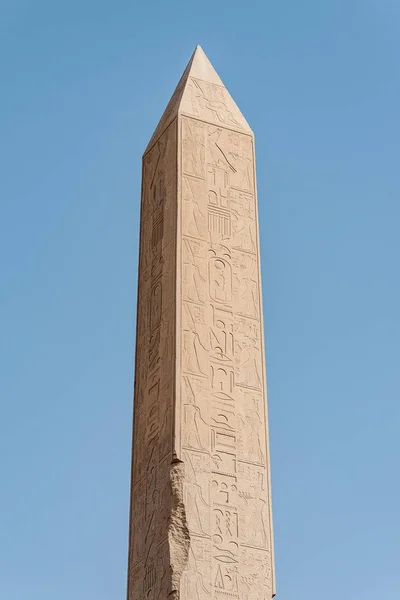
[128,118,177,600]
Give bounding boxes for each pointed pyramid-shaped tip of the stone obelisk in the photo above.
[143,45,253,155]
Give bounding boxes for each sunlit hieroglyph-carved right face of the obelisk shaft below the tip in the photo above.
[181,108,273,600]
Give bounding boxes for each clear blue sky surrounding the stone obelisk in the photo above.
[0,0,400,600]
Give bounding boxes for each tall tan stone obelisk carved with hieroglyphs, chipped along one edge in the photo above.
[128,47,275,600]
